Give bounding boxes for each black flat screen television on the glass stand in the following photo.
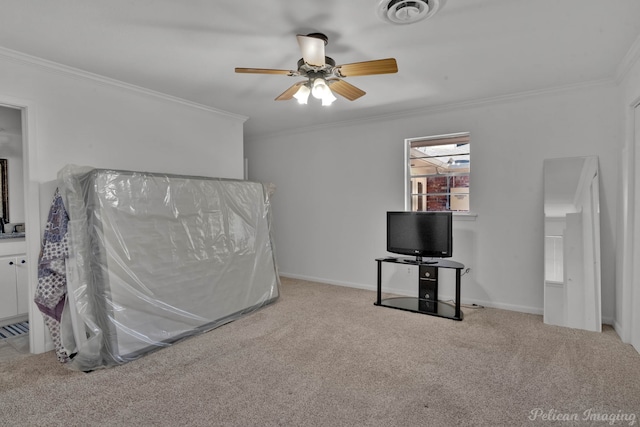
[387,211,453,263]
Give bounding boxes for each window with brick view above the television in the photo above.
[405,133,471,212]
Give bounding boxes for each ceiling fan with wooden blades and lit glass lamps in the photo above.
[236,33,398,105]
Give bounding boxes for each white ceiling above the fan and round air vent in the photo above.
[0,0,640,138]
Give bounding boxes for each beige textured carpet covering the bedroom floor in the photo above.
[0,279,640,426]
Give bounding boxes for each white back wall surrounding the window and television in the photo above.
[245,85,621,321]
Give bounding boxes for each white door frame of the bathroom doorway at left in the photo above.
[0,94,47,353]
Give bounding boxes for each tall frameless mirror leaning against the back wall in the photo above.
[544,156,602,332]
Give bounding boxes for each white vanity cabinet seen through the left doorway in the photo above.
[0,245,29,322]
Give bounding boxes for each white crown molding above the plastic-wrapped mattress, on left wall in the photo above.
[0,47,249,123]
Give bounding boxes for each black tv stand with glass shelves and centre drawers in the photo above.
[374,257,464,320]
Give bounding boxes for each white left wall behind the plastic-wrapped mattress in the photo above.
[0,49,246,352]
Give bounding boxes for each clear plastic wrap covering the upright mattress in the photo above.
[58,166,280,371]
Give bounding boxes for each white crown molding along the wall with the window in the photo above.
[245,79,617,141]
